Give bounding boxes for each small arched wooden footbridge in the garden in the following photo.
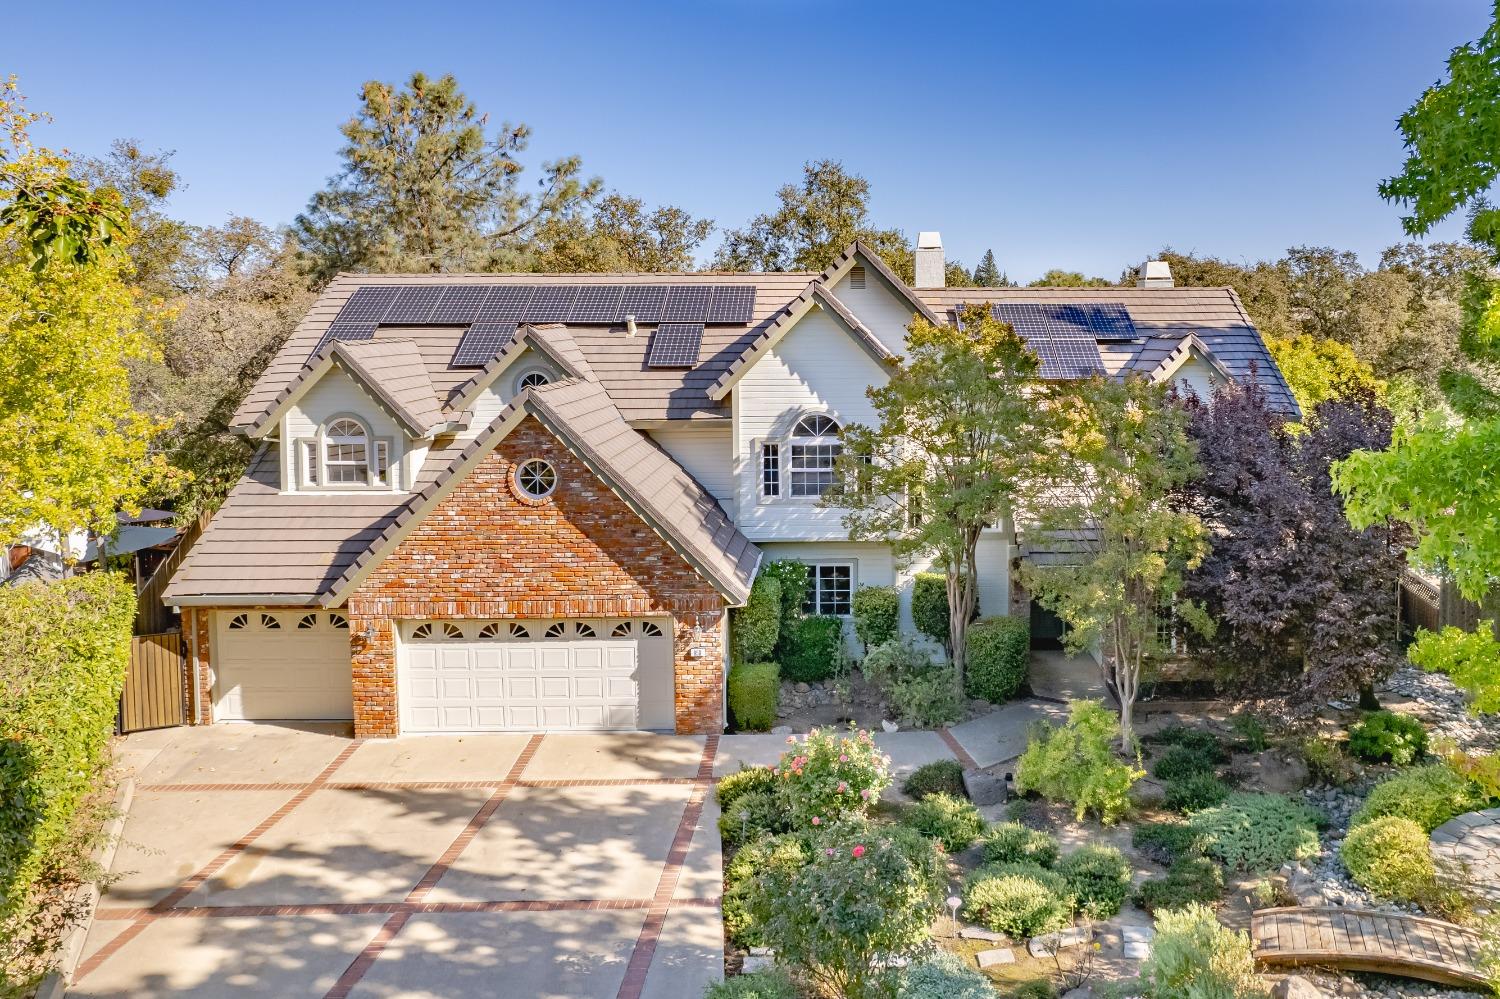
[1250,906,1488,987]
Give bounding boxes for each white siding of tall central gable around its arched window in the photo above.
[734,309,887,542]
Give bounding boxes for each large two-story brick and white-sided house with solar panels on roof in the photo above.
[164,234,1295,737]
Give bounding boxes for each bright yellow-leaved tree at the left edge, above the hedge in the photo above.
[0,80,170,543]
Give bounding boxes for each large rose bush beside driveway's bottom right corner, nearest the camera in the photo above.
[747,819,947,999]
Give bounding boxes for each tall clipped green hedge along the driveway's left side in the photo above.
[0,573,135,993]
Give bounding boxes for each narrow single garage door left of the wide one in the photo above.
[213,611,354,722]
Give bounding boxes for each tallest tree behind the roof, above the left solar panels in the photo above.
[296,72,599,284]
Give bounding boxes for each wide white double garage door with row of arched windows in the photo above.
[399,618,674,732]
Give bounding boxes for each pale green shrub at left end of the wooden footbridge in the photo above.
[1140,905,1266,999]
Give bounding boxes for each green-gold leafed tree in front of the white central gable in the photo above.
[825,308,1053,687]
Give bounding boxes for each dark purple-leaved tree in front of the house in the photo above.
[1181,383,1404,713]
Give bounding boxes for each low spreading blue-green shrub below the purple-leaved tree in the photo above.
[1188,792,1319,872]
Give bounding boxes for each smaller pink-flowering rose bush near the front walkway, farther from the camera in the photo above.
[776,729,891,830]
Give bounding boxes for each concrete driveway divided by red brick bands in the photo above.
[69,725,725,999]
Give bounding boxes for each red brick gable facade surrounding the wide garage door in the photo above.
[347,417,725,737]
